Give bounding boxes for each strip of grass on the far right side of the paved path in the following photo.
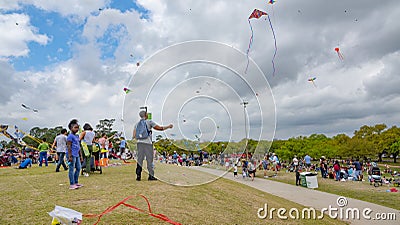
[256,171,400,209]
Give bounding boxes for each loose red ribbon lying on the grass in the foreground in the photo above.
[83,195,181,225]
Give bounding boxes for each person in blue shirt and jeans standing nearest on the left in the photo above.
[67,119,83,190]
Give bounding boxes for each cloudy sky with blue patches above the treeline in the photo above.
[0,0,400,141]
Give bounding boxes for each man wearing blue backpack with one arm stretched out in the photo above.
[133,111,173,181]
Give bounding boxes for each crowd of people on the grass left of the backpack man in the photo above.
[0,120,131,189]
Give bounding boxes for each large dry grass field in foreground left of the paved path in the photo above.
[0,163,344,224]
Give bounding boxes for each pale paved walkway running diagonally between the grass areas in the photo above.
[194,167,400,225]
